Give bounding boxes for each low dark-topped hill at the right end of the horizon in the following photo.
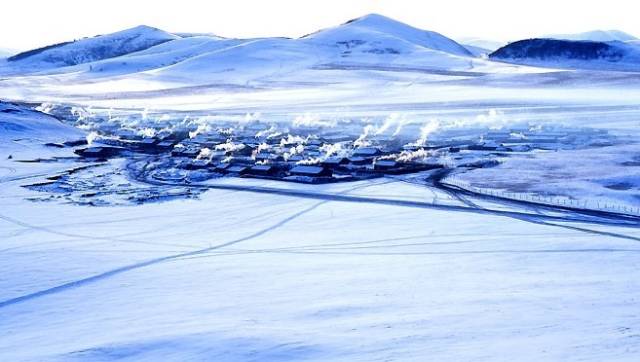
[489,39,640,70]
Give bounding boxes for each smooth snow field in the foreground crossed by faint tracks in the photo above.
[0,133,640,361]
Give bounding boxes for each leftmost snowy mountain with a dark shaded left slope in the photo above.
[8,26,180,71]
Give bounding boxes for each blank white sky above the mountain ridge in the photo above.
[0,0,640,50]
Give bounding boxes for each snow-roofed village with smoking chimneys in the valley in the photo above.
[63,117,612,184]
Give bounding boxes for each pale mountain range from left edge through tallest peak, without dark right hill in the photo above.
[0,14,482,83]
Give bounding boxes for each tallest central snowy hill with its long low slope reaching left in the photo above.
[56,14,490,85]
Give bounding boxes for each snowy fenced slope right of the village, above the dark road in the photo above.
[455,144,640,213]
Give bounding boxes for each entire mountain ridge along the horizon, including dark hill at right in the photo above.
[0,14,640,79]
